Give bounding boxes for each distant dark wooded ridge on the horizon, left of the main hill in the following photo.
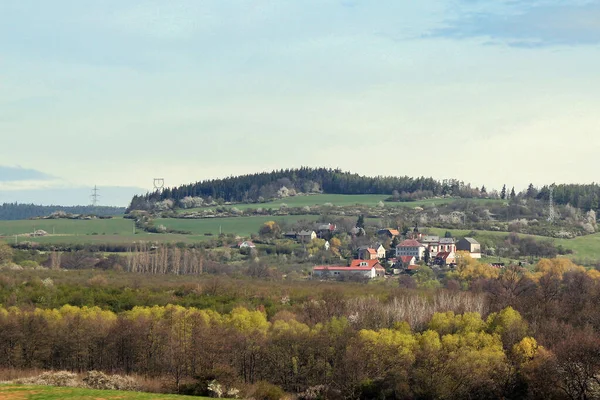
[0,203,125,220]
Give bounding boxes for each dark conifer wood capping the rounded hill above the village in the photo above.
[130,168,480,209]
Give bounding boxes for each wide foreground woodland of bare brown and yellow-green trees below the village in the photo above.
[0,239,600,399]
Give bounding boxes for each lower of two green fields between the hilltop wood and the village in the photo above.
[155,215,319,236]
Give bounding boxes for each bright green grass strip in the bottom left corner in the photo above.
[0,385,208,400]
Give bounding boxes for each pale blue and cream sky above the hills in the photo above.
[0,0,600,205]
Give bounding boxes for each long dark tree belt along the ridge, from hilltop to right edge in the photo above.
[127,167,600,216]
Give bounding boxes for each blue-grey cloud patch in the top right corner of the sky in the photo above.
[430,1,600,47]
